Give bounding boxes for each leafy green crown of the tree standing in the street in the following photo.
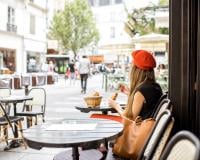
[49,0,99,56]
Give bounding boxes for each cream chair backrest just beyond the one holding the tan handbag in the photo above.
[153,98,172,120]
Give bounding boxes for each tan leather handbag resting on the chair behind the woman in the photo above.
[112,116,155,160]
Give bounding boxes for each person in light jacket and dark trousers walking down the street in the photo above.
[79,55,90,93]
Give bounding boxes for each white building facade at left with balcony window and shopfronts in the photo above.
[0,0,47,73]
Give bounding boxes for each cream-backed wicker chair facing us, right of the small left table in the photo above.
[16,88,46,127]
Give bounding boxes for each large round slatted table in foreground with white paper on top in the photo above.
[23,118,123,160]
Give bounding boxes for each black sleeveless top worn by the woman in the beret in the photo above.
[136,82,162,119]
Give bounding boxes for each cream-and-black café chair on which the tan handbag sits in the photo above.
[106,109,174,160]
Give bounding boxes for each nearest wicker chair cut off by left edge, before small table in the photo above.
[0,103,26,150]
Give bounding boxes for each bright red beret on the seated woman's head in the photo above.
[132,50,156,70]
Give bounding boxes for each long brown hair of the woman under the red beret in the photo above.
[125,65,155,119]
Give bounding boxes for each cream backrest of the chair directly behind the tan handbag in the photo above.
[138,110,174,160]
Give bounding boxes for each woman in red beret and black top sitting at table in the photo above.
[108,50,162,120]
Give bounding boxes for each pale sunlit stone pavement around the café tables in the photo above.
[0,74,126,160]
